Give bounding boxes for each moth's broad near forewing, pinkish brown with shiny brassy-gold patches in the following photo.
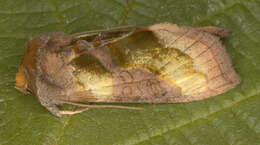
[68,23,240,103]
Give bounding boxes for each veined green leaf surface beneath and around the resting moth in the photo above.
[0,0,260,145]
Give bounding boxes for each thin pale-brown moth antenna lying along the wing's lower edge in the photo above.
[59,101,144,110]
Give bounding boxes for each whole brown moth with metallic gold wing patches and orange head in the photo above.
[15,22,241,116]
